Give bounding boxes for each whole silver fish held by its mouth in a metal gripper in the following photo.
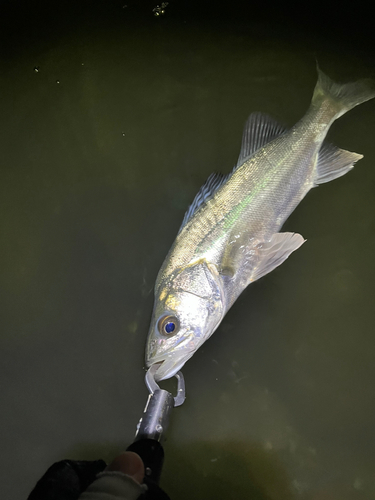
[146,68,375,380]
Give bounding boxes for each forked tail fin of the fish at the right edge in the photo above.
[312,65,375,118]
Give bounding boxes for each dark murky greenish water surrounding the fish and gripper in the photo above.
[0,0,375,500]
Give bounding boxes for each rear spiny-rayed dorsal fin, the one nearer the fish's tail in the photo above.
[235,112,288,169]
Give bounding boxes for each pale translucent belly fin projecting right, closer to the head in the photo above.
[250,233,305,282]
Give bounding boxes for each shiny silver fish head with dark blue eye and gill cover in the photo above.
[146,261,223,380]
